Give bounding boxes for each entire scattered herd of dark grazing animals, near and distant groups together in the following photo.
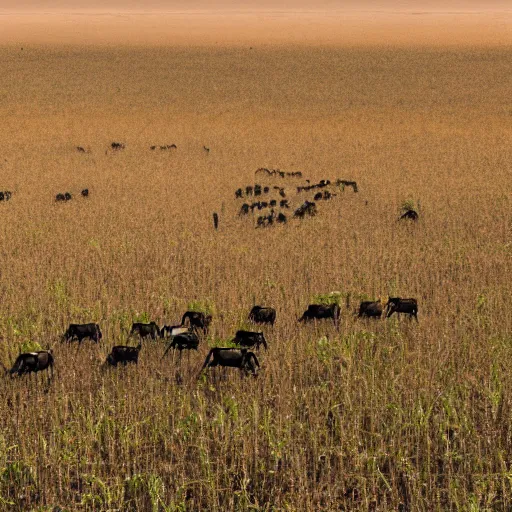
[0,142,419,379]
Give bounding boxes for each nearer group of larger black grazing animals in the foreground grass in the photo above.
[5,297,418,379]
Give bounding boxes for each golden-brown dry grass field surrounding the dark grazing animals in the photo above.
[0,7,512,512]
